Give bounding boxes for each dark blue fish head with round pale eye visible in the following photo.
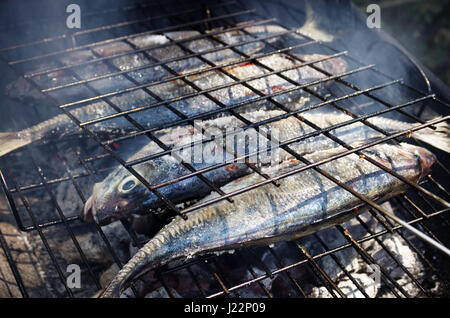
[82,162,159,225]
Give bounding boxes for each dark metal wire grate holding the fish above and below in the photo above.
[0,1,450,297]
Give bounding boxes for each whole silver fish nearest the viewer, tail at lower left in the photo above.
[102,144,435,297]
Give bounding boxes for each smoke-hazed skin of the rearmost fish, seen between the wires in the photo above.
[5,28,278,104]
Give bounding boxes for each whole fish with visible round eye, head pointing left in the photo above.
[83,111,450,224]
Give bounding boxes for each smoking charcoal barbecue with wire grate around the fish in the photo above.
[0,0,450,297]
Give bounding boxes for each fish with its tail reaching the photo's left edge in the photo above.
[0,47,346,156]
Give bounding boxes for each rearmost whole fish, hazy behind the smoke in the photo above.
[5,26,308,104]
